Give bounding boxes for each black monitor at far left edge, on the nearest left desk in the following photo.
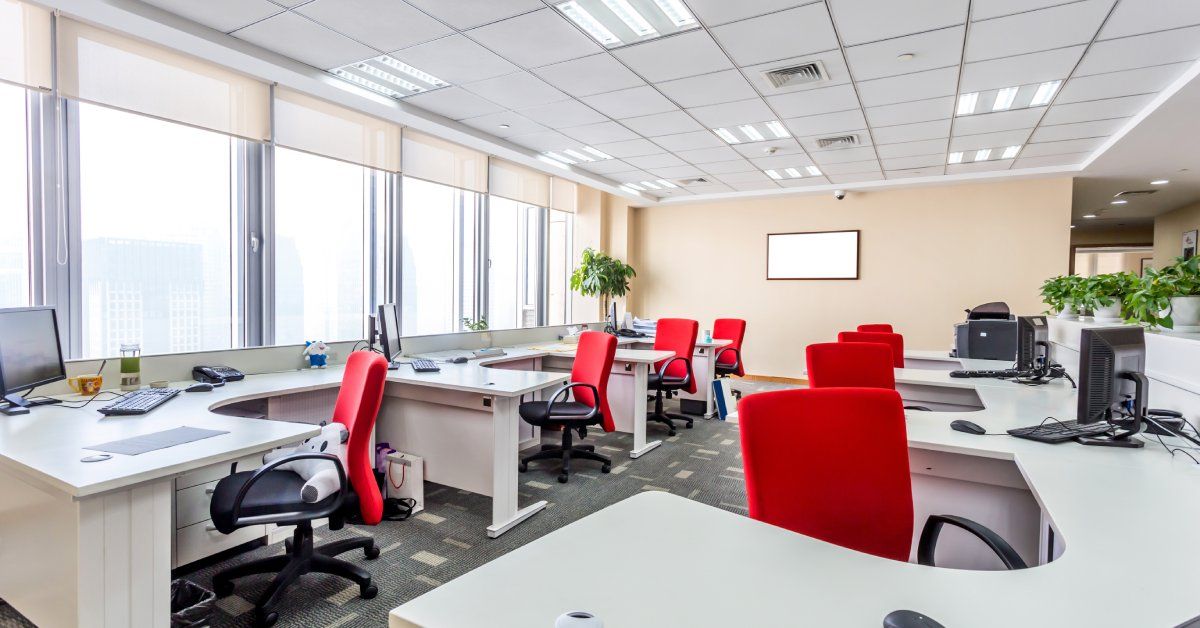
[0,307,67,414]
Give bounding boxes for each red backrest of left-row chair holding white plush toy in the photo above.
[334,351,388,525]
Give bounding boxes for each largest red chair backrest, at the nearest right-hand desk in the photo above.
[738,388,913,561]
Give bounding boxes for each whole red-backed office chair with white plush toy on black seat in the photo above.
[209,351,388,626]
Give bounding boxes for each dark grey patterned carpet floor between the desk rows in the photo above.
[0,382,786,628]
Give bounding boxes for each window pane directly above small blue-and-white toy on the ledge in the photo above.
[275,149,371,345]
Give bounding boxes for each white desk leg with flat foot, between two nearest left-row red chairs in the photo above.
[487,397,546,539]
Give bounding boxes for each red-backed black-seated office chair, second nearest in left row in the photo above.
[517,331,617,483]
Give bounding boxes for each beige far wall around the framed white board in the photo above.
[634,179,1072,377]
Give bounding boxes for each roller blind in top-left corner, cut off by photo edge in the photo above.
[0,0,52,91]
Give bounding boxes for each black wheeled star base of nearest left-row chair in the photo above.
[212,521,379,626]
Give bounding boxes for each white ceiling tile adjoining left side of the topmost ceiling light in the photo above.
[467,7,601,67]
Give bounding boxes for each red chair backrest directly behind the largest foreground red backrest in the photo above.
[806,342,896,390]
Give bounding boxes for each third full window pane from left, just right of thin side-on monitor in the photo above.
[400,178,479,336]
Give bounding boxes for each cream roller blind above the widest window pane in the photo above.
[58,17,271,140]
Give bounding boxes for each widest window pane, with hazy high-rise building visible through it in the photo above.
[79,103,238,358]
